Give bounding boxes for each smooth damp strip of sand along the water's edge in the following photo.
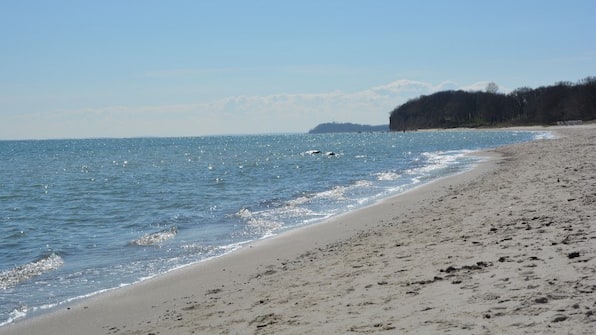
[0,143,498,335]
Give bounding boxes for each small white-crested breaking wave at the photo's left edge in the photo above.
[0,253,64,290]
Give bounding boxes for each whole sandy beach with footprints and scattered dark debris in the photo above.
[0,126,596,334]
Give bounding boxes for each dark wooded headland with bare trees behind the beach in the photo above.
[389,77,596,131]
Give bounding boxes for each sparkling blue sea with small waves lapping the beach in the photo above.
[0,130,552,326]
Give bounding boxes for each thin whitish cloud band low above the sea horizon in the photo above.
[0,80,502,138]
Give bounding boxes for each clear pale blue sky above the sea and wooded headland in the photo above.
[0,0,596,139]
